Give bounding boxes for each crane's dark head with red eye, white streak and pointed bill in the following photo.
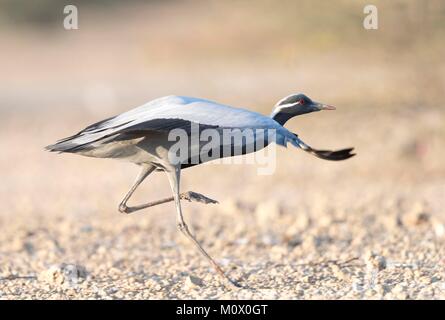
[271,93,335,125]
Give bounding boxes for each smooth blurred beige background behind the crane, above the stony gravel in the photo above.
[0,0,445,300]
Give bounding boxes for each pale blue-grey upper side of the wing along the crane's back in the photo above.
[46,96,288,152]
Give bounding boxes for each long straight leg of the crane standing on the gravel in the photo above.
[165,167,240,288]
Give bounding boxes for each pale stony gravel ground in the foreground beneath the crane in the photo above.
[0,185,445,299]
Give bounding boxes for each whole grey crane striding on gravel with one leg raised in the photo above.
[46,94,355,286]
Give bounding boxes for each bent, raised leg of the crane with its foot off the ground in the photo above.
[119,165,218,213]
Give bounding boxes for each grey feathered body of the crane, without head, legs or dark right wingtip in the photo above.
[47,96,299,167]
